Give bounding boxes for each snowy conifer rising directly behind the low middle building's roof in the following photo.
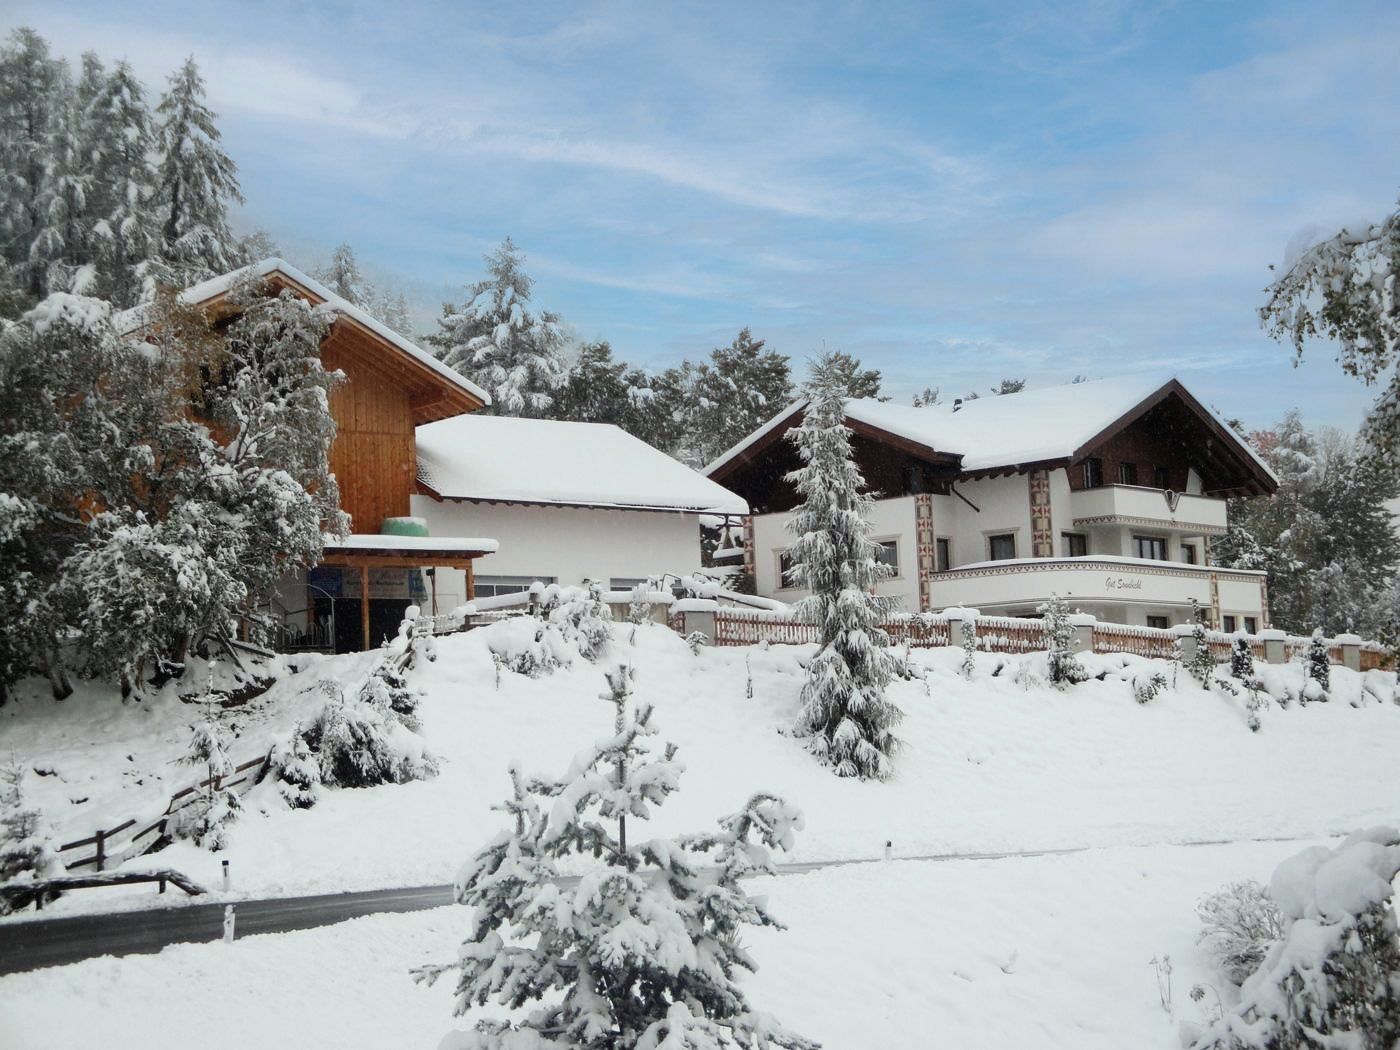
[428,237,567,416]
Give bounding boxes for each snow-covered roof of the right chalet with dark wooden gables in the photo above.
[704,375,1278,483]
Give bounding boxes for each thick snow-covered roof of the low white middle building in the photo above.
[417,414,749,514]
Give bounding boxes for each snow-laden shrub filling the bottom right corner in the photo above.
[1194,827,1400,1050]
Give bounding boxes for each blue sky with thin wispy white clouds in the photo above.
[3,0,1400,427]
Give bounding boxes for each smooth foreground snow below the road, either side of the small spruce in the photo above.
[0,840,1332,1050]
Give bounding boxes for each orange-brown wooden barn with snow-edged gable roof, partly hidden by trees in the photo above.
[119,259,497,652]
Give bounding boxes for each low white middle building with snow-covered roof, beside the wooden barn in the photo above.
[412,416,749,608]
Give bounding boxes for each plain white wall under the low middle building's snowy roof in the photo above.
[412,496,700,610]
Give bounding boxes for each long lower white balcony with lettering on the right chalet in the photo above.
[932,554,1264,616]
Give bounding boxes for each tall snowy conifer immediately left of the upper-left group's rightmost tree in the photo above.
[84,62,160,309]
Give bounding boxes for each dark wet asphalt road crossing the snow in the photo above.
[0,839,1310,974]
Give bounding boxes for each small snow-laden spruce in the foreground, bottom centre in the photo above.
[414,666,816,1050]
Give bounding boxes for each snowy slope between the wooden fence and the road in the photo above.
[8,624,1400,916]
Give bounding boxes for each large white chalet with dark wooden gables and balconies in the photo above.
[706,378,1278,630]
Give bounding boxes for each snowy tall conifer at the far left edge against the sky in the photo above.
[0,28,70,305]
